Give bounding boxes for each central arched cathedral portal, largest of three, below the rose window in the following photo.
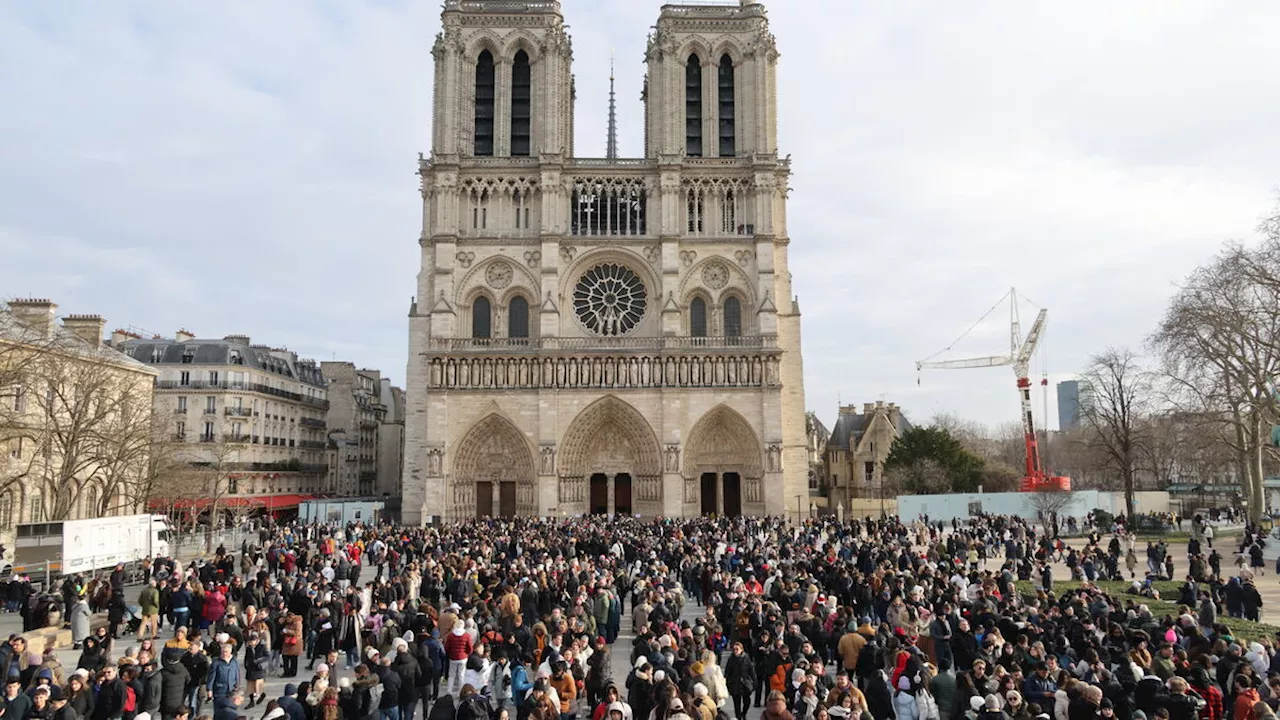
[559,396,662,515]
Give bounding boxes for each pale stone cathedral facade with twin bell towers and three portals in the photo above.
[402,0,808,524]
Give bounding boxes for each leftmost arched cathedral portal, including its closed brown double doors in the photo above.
[449,414,538,519]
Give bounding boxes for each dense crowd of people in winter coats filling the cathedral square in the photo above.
[0,516,1280,720]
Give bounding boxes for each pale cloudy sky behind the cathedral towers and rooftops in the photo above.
[0,0,1280,425]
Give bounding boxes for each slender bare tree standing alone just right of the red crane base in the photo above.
[1080,348,1153,518]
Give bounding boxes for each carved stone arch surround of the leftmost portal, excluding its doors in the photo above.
[449,414,538,518]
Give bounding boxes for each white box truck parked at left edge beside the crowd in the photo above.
[4,515,172,577]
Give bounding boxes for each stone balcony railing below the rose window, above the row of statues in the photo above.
[429,334,778,352]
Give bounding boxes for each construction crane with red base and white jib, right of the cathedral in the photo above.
[915,290,1071,492]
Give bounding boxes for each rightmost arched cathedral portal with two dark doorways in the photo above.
[684,405,764,516]
